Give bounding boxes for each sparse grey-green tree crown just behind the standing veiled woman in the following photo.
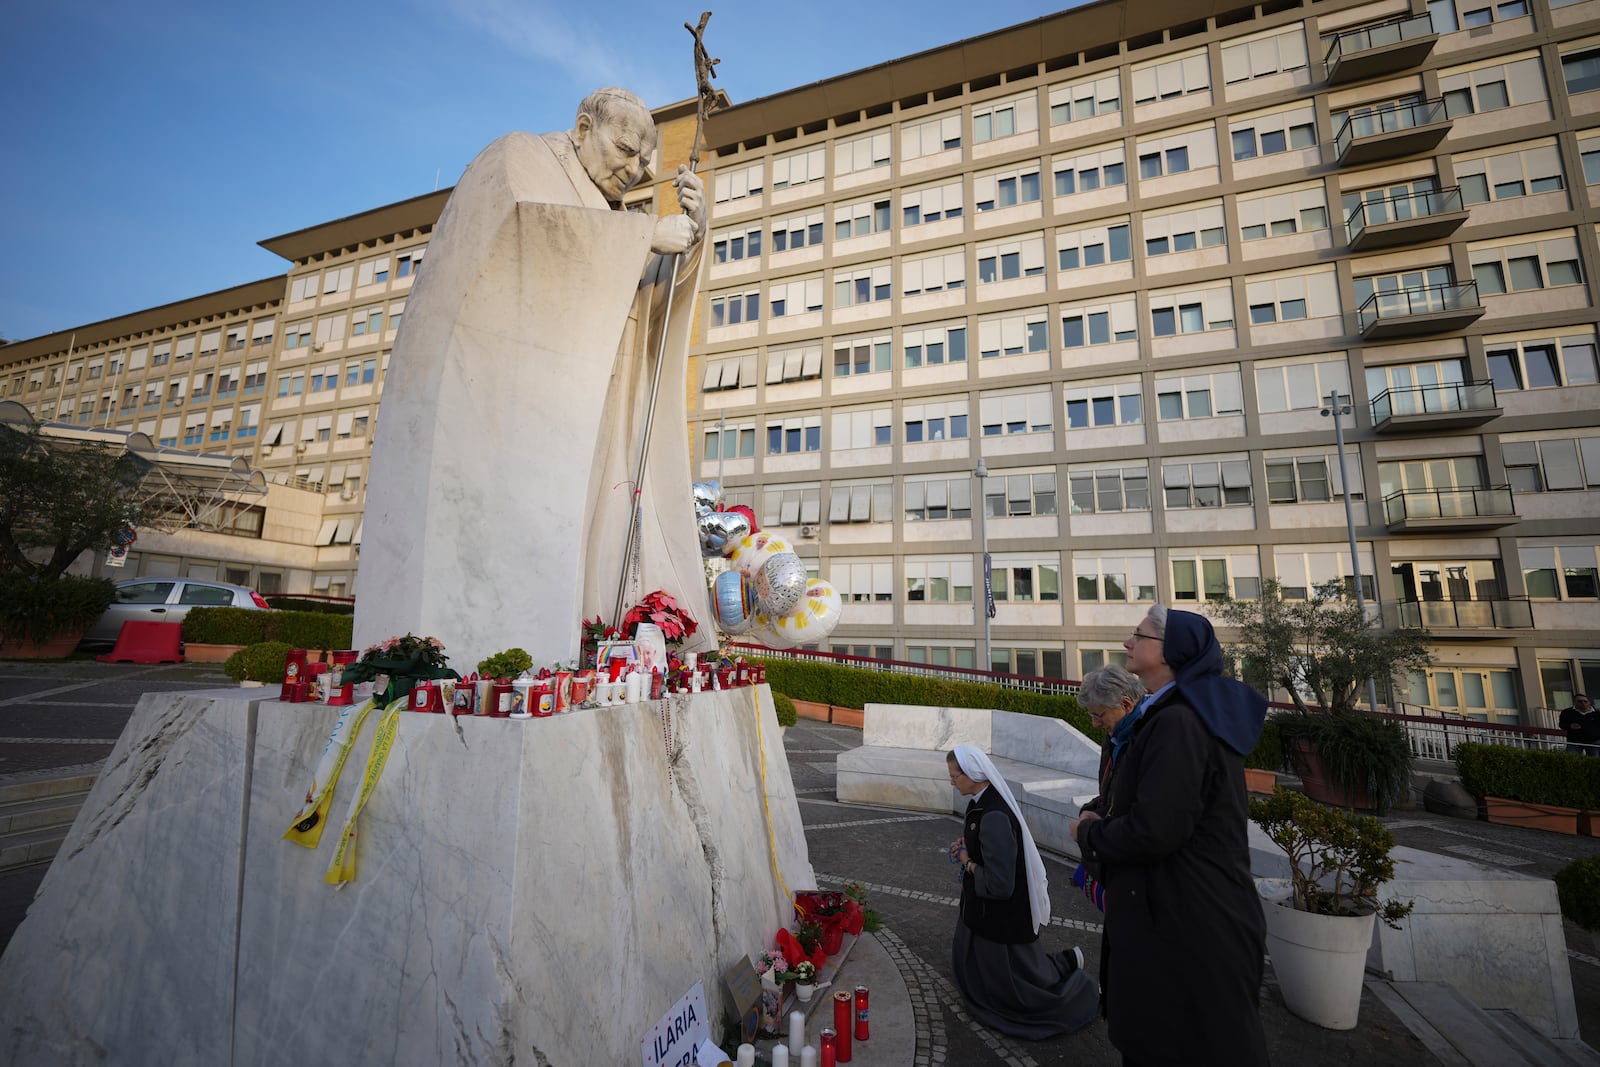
[1214,579,1434,713]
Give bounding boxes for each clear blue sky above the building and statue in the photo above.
[0,0,1077,341]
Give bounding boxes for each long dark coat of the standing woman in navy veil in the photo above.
[1078,686,1267,1067]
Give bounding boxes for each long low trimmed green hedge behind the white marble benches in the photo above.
[760,659,1104,741]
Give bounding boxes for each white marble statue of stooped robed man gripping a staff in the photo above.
[355,88,714,673]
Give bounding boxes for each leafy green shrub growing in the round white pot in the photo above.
[1250,789,1411,929]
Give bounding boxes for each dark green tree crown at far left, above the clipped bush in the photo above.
[0,426,150,577]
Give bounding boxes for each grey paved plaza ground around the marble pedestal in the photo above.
[0,661,1600,1067]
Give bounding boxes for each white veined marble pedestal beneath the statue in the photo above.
[0,686,814,1067]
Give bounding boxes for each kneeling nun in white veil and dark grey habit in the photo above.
[946,744,1099,1040]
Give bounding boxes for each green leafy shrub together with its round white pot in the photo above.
[1250,789,1411,1030]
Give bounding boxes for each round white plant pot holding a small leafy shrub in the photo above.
[1261,880,1374,1030]
